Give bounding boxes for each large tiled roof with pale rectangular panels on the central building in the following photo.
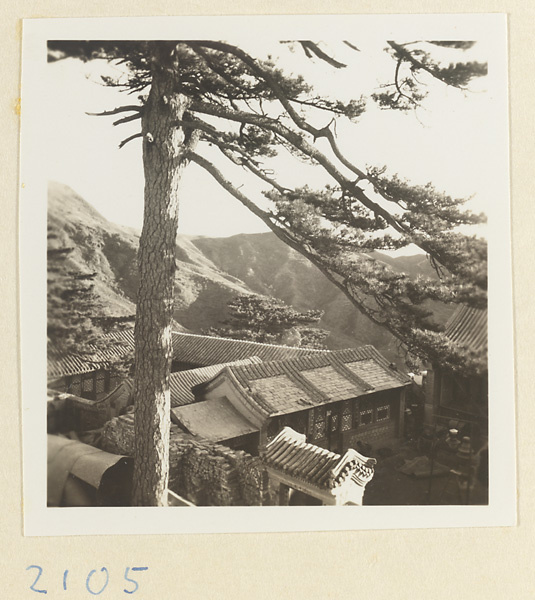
[194,346,411,418]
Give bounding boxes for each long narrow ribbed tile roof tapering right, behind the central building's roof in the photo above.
[173,332,329,366]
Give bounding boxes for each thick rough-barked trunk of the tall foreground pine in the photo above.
[132,42,196,506]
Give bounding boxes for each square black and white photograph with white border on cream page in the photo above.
[21,14,515,535]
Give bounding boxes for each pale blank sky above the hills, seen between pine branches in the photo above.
[43,40,493,237]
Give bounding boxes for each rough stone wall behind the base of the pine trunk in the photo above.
[101,414,276,506]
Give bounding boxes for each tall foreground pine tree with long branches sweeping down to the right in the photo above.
[49,41,486,505]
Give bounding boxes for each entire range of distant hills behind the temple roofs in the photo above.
[48,183,451,360]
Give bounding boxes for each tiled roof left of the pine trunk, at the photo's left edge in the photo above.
[47,327,134,378]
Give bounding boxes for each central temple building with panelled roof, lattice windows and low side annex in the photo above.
[171,346,411,455]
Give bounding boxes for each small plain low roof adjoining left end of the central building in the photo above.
[171,397,258,442]
